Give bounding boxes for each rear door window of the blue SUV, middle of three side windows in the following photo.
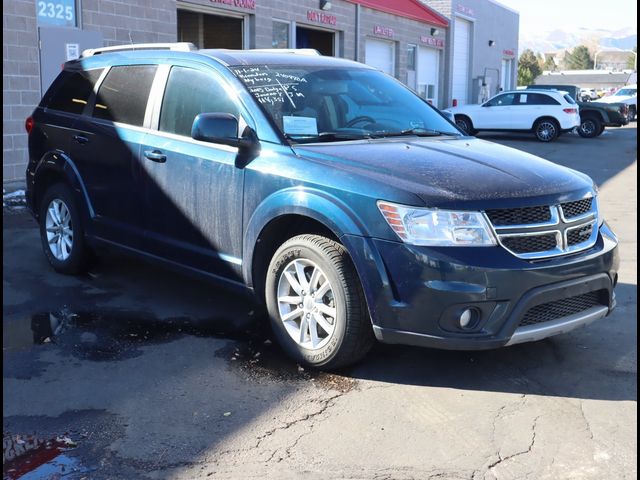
[93,65,156,126]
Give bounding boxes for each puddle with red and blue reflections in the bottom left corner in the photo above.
[2,433,92,480]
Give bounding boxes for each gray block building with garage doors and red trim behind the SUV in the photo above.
[3,0,518,181]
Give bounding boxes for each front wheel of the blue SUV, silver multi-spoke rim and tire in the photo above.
[265,235,374,370]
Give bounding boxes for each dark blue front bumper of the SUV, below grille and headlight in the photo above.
[343,223,619,350]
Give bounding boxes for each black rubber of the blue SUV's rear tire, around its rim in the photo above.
[38,183,91,275]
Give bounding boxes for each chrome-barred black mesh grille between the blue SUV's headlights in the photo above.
[485,197,598,260]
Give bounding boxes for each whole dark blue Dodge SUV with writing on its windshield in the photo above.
[26,44,618,368]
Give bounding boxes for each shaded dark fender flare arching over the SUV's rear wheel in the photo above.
[33,150,95,218]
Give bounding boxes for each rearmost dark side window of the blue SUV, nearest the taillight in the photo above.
[40,68,103,114]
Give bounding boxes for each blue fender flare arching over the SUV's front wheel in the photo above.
[242,187,367,286]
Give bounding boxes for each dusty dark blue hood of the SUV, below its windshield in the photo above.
[294,137,594,208]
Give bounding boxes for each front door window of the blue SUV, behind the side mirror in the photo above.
[159,67,239,137]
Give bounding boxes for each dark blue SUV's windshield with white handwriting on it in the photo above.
[232,65,461,143]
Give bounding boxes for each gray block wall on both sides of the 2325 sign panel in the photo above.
[2,0,176,181]
